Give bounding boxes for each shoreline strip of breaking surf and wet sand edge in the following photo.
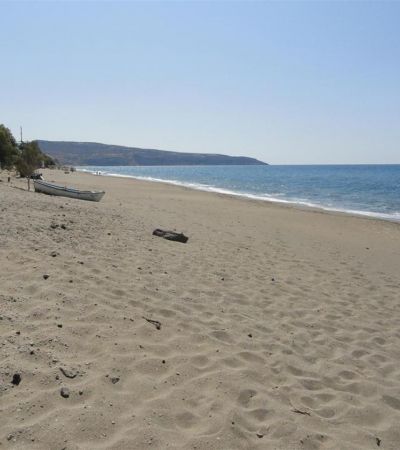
[76,166,400,225]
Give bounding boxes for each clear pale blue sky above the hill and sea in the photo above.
[0,0,400,164]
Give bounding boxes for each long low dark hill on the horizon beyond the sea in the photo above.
[37,140,266,166]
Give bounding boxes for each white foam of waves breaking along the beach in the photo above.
[76,168,400,222]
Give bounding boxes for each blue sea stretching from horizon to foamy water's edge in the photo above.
[78,165,400,221]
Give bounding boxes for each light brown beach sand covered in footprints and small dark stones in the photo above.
[0,171,400,450]
